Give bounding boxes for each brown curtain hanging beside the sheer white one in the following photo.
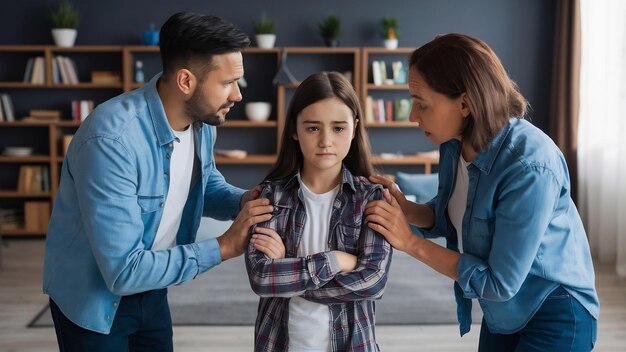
[549,0,580,202]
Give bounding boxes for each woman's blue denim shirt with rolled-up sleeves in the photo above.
[416,119,599,335]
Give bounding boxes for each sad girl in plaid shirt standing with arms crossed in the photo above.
[246,73,391,352]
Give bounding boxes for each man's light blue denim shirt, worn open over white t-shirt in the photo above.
[43,75,243,334]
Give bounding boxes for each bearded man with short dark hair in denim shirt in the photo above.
[43,13,272,351]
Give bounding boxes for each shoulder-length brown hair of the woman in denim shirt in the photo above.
[409,33,528,152]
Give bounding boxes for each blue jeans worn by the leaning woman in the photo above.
[478,286,597,352]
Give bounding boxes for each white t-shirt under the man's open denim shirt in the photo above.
[152,126,194,249]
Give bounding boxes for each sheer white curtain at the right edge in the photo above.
[578,0,626,277]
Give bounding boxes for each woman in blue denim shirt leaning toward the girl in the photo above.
[366,34,599,351]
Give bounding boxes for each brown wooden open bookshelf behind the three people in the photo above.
[0,45,438,236]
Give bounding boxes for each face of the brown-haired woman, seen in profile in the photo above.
[409,68,470,144]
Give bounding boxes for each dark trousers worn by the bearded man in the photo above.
[50,289,174,352]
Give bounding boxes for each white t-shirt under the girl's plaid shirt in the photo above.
[289,181,339,352]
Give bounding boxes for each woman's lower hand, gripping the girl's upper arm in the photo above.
[365,193,415,252]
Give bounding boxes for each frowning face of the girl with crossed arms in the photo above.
[293,98,355,173]
